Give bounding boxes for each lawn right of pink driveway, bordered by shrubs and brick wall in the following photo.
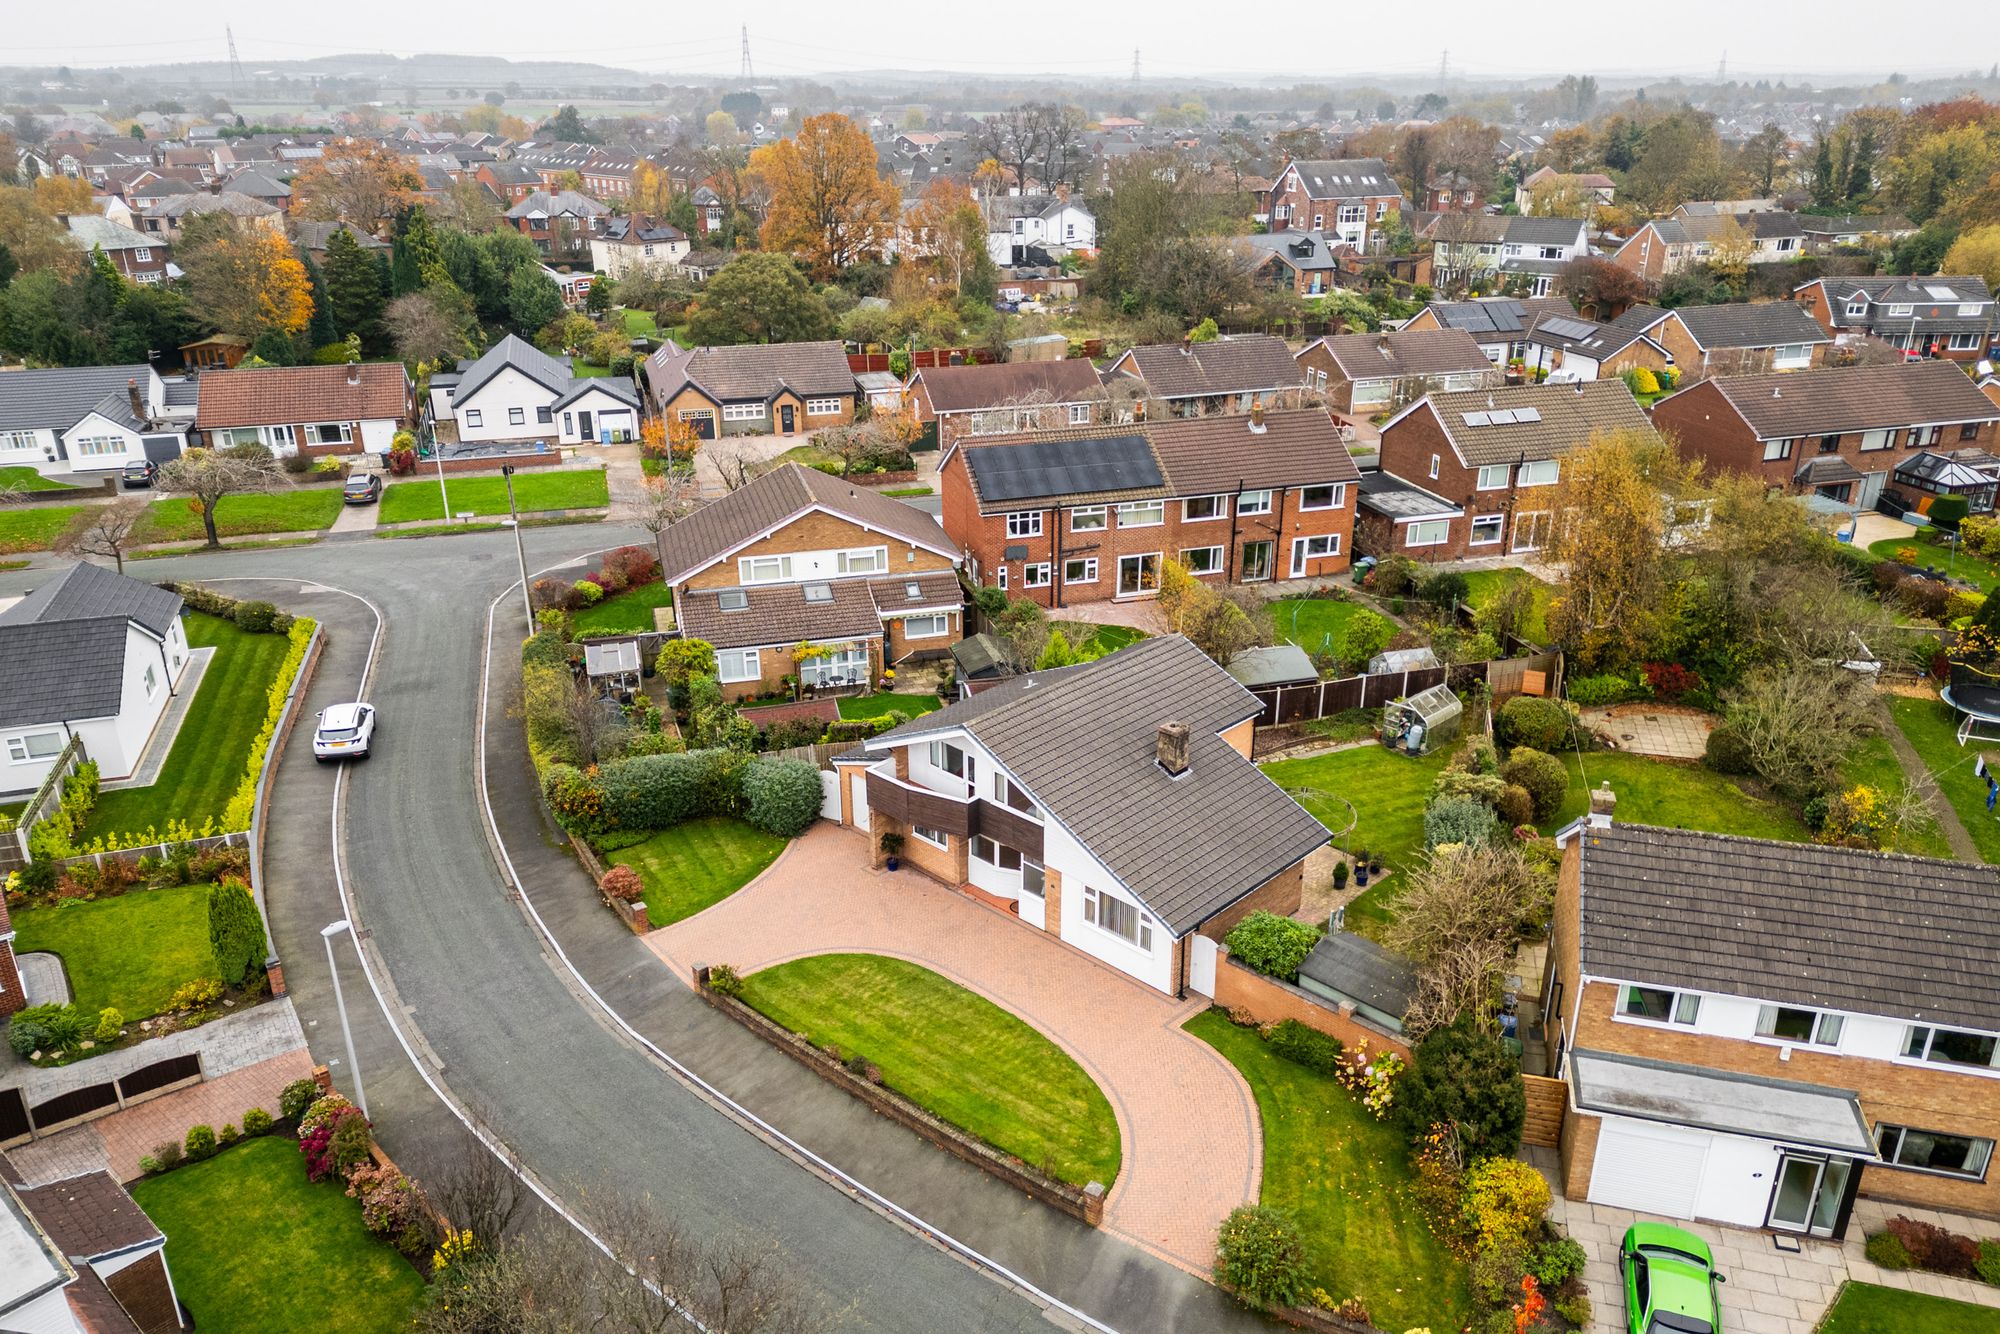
[1186,1010,1470,1332]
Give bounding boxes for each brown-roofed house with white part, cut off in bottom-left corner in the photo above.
[0,1152,184,1334]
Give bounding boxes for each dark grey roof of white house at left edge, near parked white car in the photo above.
[0,564,180,726]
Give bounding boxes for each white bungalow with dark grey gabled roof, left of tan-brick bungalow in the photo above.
[442,334,640,444]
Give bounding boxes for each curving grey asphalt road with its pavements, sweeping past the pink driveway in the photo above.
[0,528,1260,1334]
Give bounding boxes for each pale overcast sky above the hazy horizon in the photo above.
[0,0,2000,82]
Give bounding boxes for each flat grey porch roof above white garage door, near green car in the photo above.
[1570,1052,1876,1160]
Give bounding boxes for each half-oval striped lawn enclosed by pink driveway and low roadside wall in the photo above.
[744,954,1120,1188]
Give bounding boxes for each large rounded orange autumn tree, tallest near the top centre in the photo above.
[750,112,902,282]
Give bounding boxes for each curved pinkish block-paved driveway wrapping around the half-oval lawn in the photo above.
[646,822,1264,1274]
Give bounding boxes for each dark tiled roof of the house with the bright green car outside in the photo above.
[1578,824,2000,1030]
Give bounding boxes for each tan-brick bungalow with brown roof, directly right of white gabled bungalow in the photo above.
[646,342,860,440]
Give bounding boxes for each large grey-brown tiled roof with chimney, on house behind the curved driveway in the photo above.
[868,634,1326,936]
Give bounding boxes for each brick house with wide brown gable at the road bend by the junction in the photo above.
[660,464,966,698]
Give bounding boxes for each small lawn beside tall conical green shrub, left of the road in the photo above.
[14,884,216,1022]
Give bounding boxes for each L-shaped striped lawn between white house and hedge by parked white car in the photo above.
[78,612,288,842]
